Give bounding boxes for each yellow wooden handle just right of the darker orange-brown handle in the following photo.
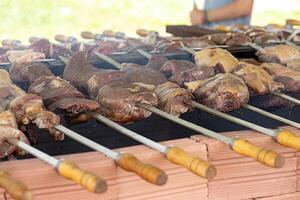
[166,147,217,179]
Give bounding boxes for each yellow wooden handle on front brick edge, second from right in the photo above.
[232,138,284,168]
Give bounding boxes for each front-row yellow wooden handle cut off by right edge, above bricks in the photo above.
[275,130,300,151]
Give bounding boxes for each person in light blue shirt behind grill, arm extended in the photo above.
[190,0,254,27]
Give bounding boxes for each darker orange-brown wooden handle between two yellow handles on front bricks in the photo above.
[117,153,168,185]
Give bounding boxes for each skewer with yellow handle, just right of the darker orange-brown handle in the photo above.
[93,113,216,179]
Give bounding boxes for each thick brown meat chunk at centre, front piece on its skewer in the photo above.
[96,81,158,123]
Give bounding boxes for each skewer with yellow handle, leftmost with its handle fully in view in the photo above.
[7,138,107,193]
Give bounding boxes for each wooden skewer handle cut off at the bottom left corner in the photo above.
[0,170,33,200]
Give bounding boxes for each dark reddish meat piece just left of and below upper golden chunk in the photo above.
[159,60,215,86]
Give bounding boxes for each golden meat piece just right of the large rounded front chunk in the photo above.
[233,62,284,95]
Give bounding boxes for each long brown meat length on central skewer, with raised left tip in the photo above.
[64,52,158,123]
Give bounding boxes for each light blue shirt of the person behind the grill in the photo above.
[204,0,250,26]
